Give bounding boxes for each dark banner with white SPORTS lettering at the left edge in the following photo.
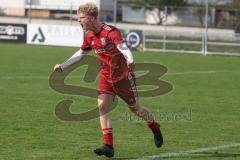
[0,23,27,43]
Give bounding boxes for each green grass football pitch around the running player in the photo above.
[0,43,240,160]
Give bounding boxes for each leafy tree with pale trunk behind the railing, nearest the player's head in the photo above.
[131,0,187,24]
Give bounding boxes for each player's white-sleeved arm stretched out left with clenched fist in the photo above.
[54,49,88,72]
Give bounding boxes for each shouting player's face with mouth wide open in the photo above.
[78,13,94,32]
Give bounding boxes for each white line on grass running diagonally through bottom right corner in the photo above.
[132,143,240,160]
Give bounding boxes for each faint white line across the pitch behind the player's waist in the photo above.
[0,70,240,80]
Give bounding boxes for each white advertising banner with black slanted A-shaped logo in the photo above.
[27,24,83,47]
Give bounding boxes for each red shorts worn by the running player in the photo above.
[98,73,138,106]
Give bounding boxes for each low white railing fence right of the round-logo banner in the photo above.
[143,31,240,56]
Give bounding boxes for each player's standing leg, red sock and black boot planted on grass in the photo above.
[94,94,114,157]
